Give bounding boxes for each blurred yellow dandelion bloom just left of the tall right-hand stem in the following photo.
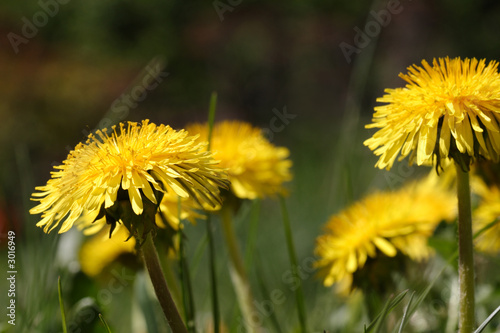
[315,173,456,290]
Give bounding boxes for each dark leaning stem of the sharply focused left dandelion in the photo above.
[141,234,187,333]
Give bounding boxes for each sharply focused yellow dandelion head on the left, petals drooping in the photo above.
[30,120,227,233]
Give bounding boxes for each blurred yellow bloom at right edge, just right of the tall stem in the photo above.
[471,177,500,254]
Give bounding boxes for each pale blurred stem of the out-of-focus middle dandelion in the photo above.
[221,205,260,332]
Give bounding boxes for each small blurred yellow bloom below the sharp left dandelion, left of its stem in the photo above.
[79,226,135,277]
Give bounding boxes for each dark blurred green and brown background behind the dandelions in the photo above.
[0,0,500,332]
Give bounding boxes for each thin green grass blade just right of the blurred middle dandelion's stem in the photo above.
[280,195,307,333]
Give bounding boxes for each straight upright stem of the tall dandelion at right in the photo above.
[456,164,475,333]
